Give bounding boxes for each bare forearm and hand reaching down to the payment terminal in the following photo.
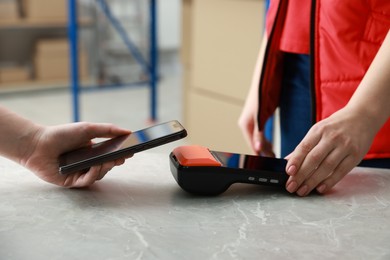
[286,30,390,196]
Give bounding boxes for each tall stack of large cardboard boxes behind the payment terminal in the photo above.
[181,0,265,154]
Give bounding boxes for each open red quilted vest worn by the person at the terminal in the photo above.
[258,0,390,159]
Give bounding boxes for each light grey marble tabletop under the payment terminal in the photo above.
[0,152,390,260]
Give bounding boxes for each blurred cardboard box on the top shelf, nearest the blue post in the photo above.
[23,0,68,22]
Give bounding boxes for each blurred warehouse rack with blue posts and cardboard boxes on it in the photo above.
[0,0,158,121]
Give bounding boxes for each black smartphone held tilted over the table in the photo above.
[59,120,187,174]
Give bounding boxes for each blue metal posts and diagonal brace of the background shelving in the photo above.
[68,0,158,122]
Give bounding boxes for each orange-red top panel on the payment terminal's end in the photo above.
[172,145,222,166]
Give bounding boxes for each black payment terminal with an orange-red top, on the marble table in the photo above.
[169,145,288,195]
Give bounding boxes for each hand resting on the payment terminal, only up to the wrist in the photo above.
[286,108,377,196]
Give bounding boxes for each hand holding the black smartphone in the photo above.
[20,123,130,188]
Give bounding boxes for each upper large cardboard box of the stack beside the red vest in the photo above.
[190,0,265,101]
